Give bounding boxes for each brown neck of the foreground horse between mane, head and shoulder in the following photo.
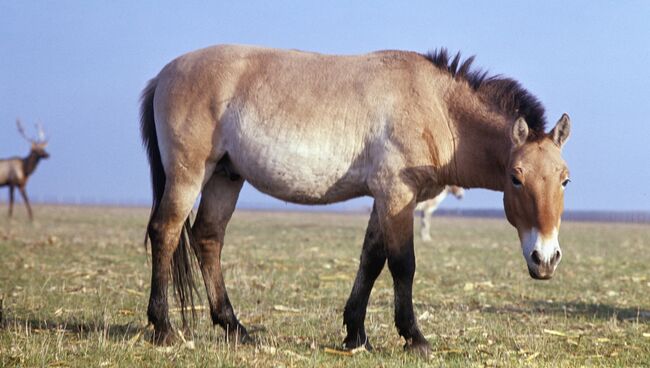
[447,90,511,191]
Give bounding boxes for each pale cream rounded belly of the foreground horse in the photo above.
[225,124,368,204]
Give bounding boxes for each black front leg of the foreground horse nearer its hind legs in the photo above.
[343,206,386,350]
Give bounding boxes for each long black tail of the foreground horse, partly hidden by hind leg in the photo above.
[140,78,197,326]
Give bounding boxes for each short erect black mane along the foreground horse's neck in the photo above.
[424,48,546,136]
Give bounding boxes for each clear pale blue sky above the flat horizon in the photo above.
[0,0,650,211]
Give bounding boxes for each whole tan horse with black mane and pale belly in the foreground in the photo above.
[141,46,569,353]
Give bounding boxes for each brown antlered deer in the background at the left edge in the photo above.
[0,119,50,221]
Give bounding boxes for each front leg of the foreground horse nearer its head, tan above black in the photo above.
[376,185,431,355]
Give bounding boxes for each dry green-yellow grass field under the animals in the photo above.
[0,206,650,367]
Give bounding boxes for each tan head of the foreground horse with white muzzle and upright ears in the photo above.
[503,114,571,280]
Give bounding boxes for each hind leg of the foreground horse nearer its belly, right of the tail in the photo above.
[192,170,251,343]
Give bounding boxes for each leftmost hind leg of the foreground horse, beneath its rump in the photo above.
[147,175,202,345]
